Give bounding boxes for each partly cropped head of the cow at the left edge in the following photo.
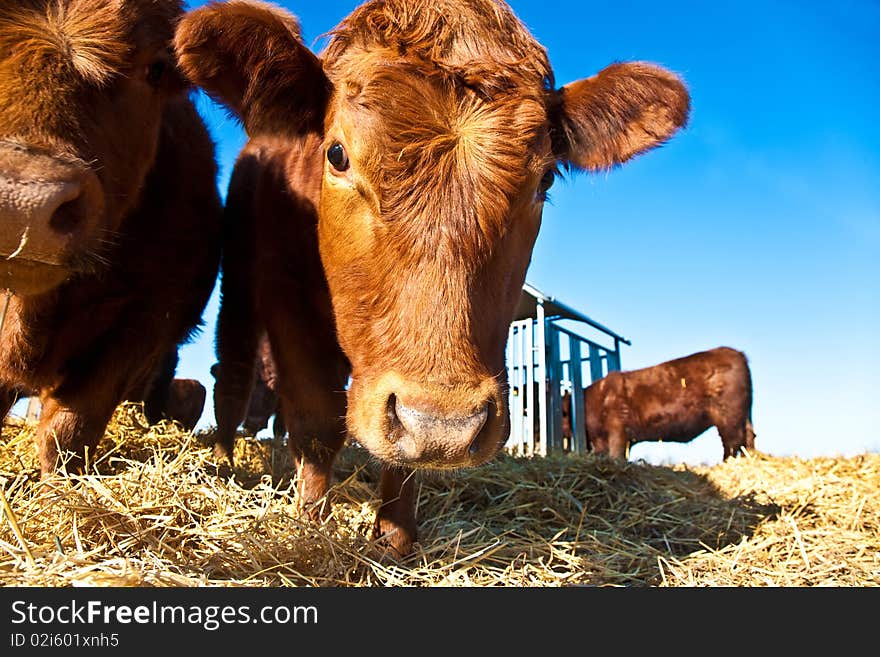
[0,0,185,296]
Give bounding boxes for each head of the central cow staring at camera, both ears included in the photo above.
[176,0,689,468]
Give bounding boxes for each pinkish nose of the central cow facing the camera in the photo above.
[387,395,489,468]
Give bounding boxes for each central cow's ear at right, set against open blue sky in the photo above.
[554,62,690,171]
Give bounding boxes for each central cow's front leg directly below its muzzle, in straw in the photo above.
[373,468,418,556]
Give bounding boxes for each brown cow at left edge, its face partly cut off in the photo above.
[0,0,222,476]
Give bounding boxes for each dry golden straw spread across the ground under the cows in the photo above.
[0,405,880,587]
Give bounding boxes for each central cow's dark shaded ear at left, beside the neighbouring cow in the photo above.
[174,0,330,136]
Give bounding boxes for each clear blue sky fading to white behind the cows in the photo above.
[167,0,880,464]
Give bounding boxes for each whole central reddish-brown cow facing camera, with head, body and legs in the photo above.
[176,0,690,553]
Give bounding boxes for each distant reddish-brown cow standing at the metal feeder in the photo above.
[562,347,755,459]
